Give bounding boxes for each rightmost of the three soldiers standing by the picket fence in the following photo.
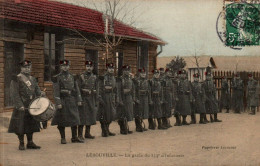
[247,74,259,115]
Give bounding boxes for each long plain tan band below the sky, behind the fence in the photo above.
[157,56,260,72]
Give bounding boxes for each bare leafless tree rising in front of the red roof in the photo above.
[58,0,145,63]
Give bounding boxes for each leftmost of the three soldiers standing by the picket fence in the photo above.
[219,77,230,113]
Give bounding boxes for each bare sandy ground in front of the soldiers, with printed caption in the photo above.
[0,112,260,166]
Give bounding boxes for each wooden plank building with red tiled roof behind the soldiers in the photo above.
[0,0,165,112]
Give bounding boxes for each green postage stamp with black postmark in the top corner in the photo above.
[226,3,260,46]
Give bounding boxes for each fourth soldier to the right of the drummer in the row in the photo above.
[117,65,135,135]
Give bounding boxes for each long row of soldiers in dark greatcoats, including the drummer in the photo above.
[9,60,221,150]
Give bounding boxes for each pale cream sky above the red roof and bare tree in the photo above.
[56,0,260,57]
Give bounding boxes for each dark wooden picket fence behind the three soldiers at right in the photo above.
[213,71,260,110]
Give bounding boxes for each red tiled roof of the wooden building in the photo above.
[0,0,165,44]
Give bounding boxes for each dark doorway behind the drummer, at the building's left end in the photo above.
[4,42,24,107]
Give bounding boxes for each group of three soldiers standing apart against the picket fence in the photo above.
[219,73,260,115]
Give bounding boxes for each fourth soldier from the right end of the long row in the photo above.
[161,68,174,128]
